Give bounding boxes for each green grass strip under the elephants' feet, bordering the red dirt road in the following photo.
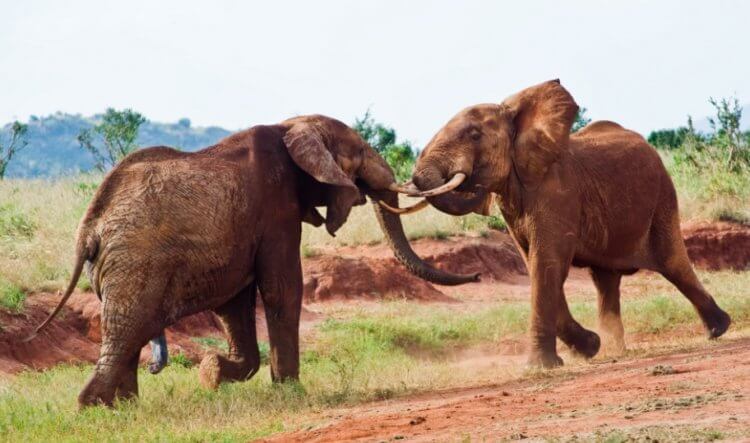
[0,272,750,441]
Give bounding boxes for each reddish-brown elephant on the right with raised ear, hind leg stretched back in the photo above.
[390,80,731,367]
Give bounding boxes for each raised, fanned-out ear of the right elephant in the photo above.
[503,80,578,187]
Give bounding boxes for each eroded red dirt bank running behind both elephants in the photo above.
[0,223,750,373]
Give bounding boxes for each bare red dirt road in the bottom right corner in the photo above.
[268,335,750,442]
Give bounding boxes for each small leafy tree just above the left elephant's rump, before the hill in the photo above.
[77,108,146,171]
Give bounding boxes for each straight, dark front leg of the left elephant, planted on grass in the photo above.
[257,227,302,382]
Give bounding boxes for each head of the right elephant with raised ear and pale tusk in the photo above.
[396,80,578,215]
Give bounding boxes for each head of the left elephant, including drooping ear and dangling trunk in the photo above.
[281,115,478,285]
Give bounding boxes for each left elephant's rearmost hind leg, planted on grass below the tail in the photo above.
[78,295,162,407]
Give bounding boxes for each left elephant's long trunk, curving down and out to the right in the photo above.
[370,191,479,285]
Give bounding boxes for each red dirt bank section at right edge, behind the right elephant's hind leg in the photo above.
[682,223,750,271]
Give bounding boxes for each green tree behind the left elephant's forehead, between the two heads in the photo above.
[353,109,417,181]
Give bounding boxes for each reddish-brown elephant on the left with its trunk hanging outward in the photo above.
[37,115,476,405]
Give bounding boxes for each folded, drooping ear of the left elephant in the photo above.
[284,121,360,235]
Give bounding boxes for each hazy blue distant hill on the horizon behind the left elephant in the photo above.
[2,112,230,178]
